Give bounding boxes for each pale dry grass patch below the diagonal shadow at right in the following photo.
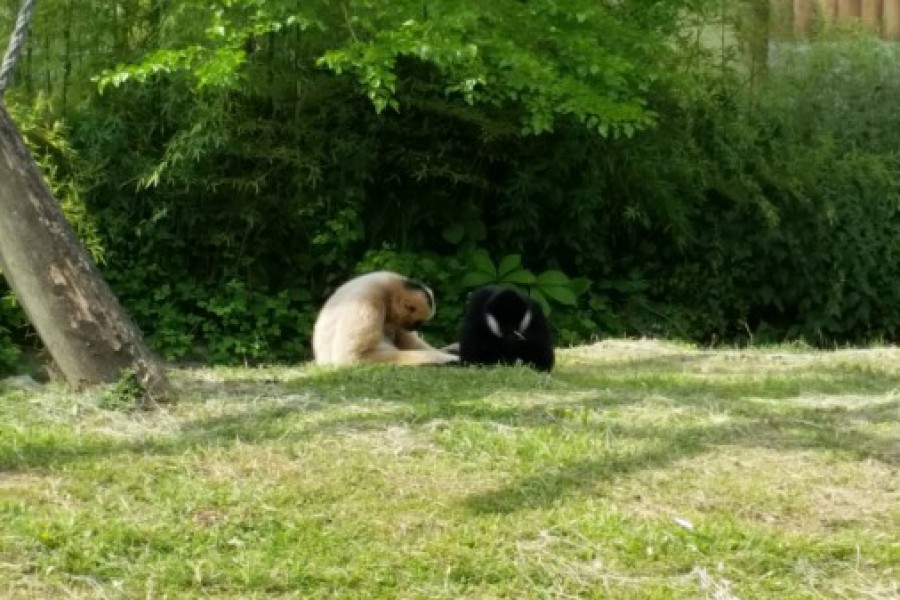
[614,446,900,535]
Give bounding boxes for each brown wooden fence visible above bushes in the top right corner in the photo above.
[773,0,900,40]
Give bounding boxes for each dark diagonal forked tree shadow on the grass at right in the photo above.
[464,386,900,514]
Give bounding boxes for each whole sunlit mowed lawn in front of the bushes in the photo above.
[0,341,900,600]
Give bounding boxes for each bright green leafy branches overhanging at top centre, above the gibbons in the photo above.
[318,0,657,137]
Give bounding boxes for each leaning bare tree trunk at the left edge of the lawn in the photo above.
[0,102,175,404]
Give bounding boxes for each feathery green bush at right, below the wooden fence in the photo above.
[652,37,900,344]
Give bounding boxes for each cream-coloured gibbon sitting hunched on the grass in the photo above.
[313,271,459,365]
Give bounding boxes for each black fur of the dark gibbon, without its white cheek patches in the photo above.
[459,285,554,372]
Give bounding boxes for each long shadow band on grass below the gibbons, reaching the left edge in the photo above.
[0,367,559,473]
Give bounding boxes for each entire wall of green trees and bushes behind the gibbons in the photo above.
[0,0,900,368]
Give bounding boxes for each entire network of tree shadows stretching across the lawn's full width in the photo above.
[0,357,900,513]
